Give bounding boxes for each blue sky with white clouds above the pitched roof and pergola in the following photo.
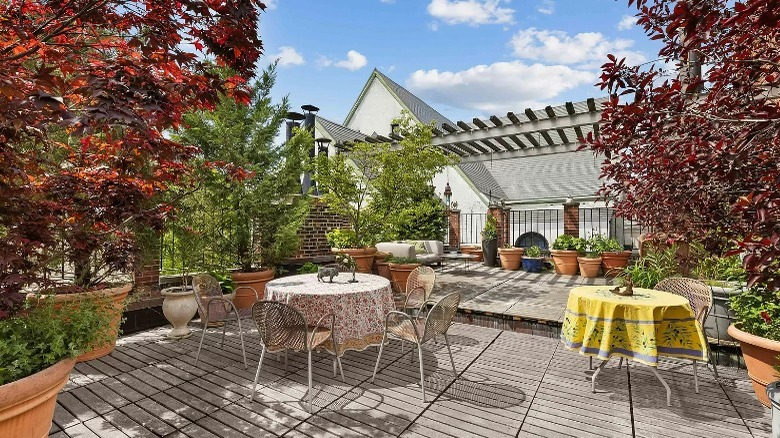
[260,0,659,122]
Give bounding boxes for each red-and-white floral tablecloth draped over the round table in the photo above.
[265,273,395,355]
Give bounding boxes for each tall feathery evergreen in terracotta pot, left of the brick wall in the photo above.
[176,64,313,309]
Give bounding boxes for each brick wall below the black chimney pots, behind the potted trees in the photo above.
[292,200,349,260]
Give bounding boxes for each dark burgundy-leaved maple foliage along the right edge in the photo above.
[587,0,780,290]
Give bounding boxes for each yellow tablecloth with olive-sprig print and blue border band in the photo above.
[561,286,707,367]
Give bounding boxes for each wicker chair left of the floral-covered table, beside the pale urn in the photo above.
[192,274,259,368]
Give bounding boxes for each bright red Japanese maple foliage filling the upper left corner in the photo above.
[0,0,265,317]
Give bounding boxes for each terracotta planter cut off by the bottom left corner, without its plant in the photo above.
[0,359,76,438]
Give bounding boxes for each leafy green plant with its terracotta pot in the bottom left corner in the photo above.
[0,296,113,437]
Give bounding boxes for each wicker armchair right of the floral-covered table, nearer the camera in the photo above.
[371,292,460,403]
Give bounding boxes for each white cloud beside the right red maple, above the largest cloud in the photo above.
[509,27,647,68]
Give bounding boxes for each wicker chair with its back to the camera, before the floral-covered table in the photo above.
[249,301,345,412]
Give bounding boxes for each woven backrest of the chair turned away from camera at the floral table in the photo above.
[252,301,308,352]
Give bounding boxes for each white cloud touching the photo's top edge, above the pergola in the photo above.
[428,0,515,26]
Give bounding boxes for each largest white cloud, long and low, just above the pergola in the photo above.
[406,61,597,113]
